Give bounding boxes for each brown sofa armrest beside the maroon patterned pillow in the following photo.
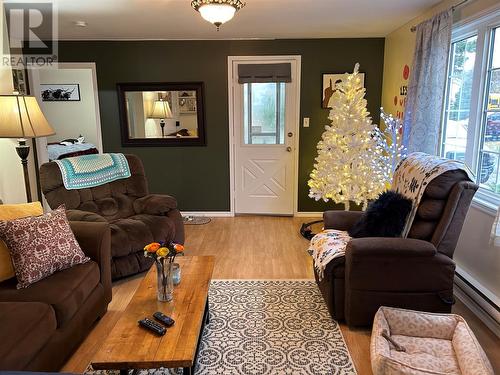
[69,221,112,303]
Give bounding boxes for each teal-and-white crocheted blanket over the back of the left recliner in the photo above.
[55,154,130,190]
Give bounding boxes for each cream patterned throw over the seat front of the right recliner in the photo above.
[307,229,351,280]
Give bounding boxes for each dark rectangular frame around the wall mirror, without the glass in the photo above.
[116,82,206,147]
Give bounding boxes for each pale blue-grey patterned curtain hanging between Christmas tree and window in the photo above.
[403,9,453,155]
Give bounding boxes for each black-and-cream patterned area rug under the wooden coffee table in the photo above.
[87,280,356,375]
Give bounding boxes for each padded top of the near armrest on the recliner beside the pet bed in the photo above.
[346,237,437,258]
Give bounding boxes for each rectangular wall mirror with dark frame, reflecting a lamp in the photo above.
[117,82,205,146]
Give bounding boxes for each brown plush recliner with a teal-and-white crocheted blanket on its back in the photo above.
[40,155,184,280]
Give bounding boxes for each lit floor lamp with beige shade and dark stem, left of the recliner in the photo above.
[0,95,55,202]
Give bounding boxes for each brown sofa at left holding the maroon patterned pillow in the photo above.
[0,222,111,371]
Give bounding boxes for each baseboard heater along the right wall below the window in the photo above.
[453,267,500,338]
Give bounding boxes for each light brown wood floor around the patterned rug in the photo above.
[62,216,500,375]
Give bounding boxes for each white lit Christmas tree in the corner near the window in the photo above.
[308,64,392,210]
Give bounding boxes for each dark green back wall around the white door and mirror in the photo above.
[59,40,384,211]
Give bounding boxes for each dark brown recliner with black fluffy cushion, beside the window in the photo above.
[315,170,478,326]
